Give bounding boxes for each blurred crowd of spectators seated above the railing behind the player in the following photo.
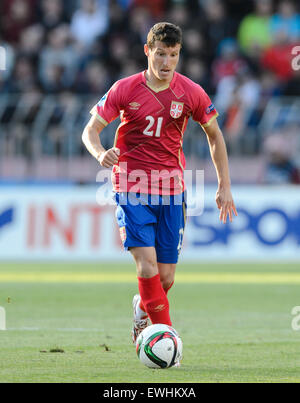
[0,0,300,185]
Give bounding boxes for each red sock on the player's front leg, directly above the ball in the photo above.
[138,274,172,326]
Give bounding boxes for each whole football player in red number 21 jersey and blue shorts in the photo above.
[82,22,237,348]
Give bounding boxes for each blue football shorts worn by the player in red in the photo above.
[114,193,186,263]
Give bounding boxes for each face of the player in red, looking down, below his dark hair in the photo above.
[145,41,181,83]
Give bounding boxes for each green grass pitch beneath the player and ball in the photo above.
[0,263,300,383]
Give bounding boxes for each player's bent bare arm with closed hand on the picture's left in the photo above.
[82,114,120,168]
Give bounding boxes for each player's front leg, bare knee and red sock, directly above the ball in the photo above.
[130,247,171,326]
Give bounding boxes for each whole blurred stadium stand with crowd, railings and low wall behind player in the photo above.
[0,0,300,183]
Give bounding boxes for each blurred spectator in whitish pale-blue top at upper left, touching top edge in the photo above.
[71,0,109,48]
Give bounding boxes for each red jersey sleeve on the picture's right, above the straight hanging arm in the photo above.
[192,85,219,127]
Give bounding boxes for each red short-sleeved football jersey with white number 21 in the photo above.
[91,72,218,195]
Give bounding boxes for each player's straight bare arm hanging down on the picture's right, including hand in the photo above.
[202,119,237,224]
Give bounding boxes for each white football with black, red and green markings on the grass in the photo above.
[136,324,182,368]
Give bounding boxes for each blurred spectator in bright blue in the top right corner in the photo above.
[270,0,300,43]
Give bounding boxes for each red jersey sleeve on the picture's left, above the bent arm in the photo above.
[90,82,122,126]
